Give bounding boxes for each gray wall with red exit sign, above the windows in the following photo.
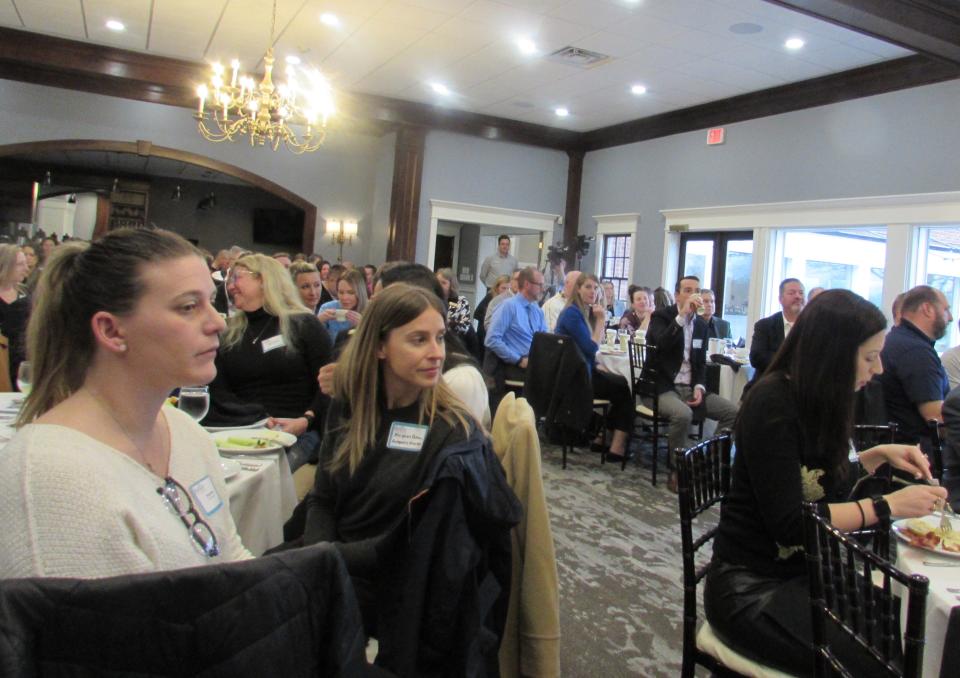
[579,81,960,285]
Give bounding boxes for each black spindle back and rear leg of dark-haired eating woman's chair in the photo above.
[675,432,732,676]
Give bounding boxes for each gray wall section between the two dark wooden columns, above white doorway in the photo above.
[417,131,567,262]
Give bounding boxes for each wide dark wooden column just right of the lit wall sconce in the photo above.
[387,126,427,261]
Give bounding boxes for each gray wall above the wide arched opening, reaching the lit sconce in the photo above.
[0,80,382,261]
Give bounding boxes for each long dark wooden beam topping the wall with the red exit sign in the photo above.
[580,55,960,151]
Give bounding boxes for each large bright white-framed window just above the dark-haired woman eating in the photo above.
[767,226,887,312]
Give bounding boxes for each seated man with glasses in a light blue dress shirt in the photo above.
[483,266,547,394]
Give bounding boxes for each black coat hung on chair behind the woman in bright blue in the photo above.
[523,332,593,434]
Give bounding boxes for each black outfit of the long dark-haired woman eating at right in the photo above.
[704,375,885,676]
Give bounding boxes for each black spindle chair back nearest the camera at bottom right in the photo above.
[803,503,929,678]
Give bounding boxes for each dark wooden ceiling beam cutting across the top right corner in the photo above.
[766,0,960,64]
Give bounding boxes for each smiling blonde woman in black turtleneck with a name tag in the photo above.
[207,254,331,470]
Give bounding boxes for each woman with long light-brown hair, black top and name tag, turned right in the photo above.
[303,284,512,635]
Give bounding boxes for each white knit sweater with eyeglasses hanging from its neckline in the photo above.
[0,407,252,578]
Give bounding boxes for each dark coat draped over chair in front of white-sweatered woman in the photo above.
[0,544,384,678]
